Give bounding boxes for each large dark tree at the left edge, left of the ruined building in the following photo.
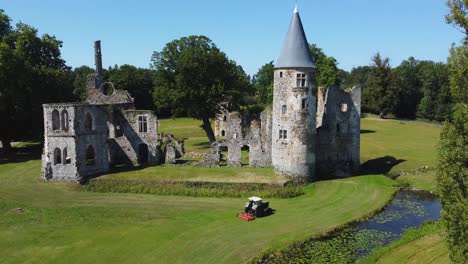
[0,11,72,152]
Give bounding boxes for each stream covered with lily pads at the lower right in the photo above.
[263,190,441,263]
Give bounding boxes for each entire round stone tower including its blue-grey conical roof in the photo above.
[272,8,317,182]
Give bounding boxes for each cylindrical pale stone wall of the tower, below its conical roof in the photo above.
[272,69,316,181]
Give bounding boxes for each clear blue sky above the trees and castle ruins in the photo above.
[0,0,462,74]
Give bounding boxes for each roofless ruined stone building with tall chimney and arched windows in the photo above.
[42,41,162,181]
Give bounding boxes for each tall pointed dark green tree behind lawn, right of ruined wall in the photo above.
[362,53,397,118]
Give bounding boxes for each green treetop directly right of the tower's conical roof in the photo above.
[309,44,341,87]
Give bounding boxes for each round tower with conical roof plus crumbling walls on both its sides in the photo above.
[201,9,361,182]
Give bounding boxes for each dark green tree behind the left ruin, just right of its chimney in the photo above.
[108,64,154,109]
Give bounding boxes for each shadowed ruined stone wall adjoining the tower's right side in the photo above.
[316,86,360,177]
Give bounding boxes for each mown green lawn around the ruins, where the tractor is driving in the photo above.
[0,119,446,263]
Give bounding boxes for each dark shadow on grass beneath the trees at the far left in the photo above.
[0,142,42,165]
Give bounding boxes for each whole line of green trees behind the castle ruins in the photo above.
[0,6,464,150]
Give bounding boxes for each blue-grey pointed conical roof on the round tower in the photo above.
[275,7,315,68]
